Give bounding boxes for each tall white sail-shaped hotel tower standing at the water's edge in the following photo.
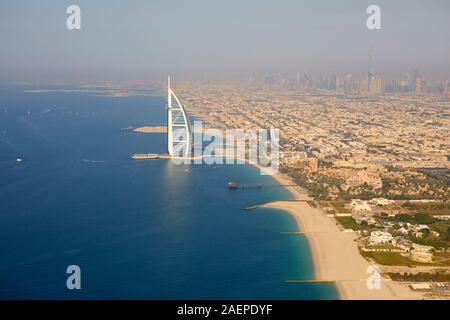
[167,77,192,157]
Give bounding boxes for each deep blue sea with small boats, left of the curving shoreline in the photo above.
[0,85,338,299]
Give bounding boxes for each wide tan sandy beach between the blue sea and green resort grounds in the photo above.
[261,174,423,300]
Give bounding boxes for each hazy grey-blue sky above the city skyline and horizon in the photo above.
[0,0,450,80]
